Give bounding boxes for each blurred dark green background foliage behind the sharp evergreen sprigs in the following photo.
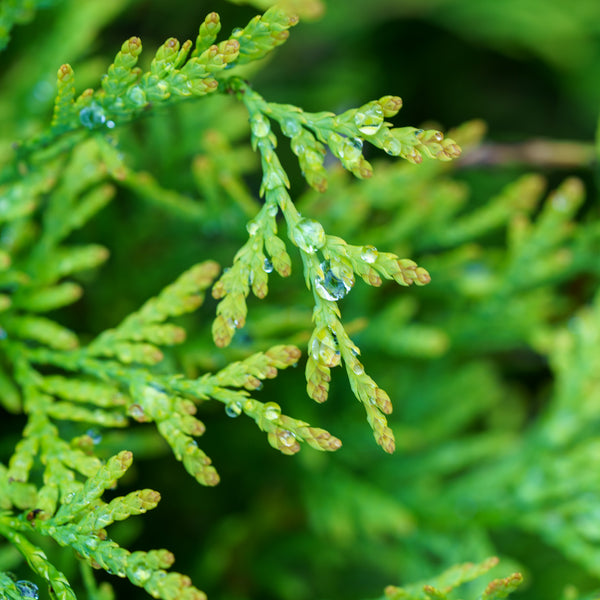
[0,0,600,600]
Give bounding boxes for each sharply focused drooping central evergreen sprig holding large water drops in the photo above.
[213,79,460,452]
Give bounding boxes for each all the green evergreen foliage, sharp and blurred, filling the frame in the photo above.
[0,0,600,600]
